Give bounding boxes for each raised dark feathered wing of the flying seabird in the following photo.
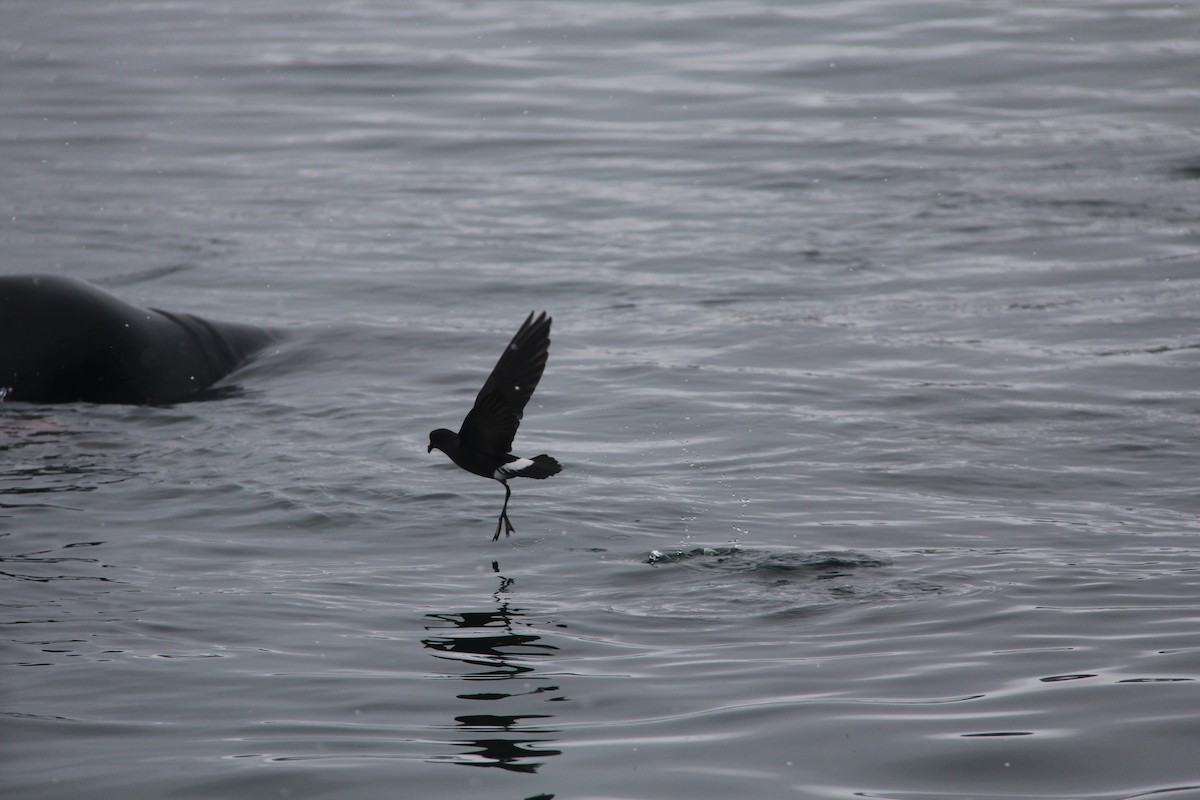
[458,312,551,456]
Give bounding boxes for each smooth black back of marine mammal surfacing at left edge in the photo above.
[0,275,276,405]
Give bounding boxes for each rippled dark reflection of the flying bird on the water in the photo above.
[421,561,568,772]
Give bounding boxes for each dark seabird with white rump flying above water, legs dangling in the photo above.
[425,312,563,542]
